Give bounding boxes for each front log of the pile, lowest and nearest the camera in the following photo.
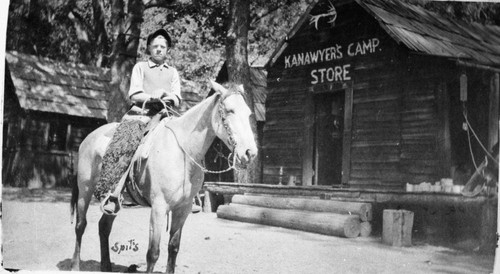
[217,204,360,238]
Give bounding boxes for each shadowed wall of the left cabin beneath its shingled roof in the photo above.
[2,112,105,188]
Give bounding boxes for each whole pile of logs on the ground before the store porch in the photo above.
[217,195,372,238]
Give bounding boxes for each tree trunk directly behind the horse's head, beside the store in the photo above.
[226,0,260,183]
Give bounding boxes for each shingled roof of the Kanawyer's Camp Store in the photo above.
[267,0,500,67]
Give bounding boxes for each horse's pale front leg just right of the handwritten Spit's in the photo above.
[146,202,168,273]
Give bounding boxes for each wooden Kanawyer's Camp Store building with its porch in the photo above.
[205,0,500,251]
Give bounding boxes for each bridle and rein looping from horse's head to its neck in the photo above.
[165,91,241,174]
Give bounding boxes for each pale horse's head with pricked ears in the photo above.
[210,81,257,166]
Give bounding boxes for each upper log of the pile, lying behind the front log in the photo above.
[232,195,373,221]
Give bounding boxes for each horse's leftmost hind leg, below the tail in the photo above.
[71,183,94,271]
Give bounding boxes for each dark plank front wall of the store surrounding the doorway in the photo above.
[263,1,456,190]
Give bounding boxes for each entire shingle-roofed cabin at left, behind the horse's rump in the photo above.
[2,51,111,188]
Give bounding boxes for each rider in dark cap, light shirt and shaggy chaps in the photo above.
[94,29,193,214]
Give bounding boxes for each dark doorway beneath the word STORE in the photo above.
[314,91,345,185]
